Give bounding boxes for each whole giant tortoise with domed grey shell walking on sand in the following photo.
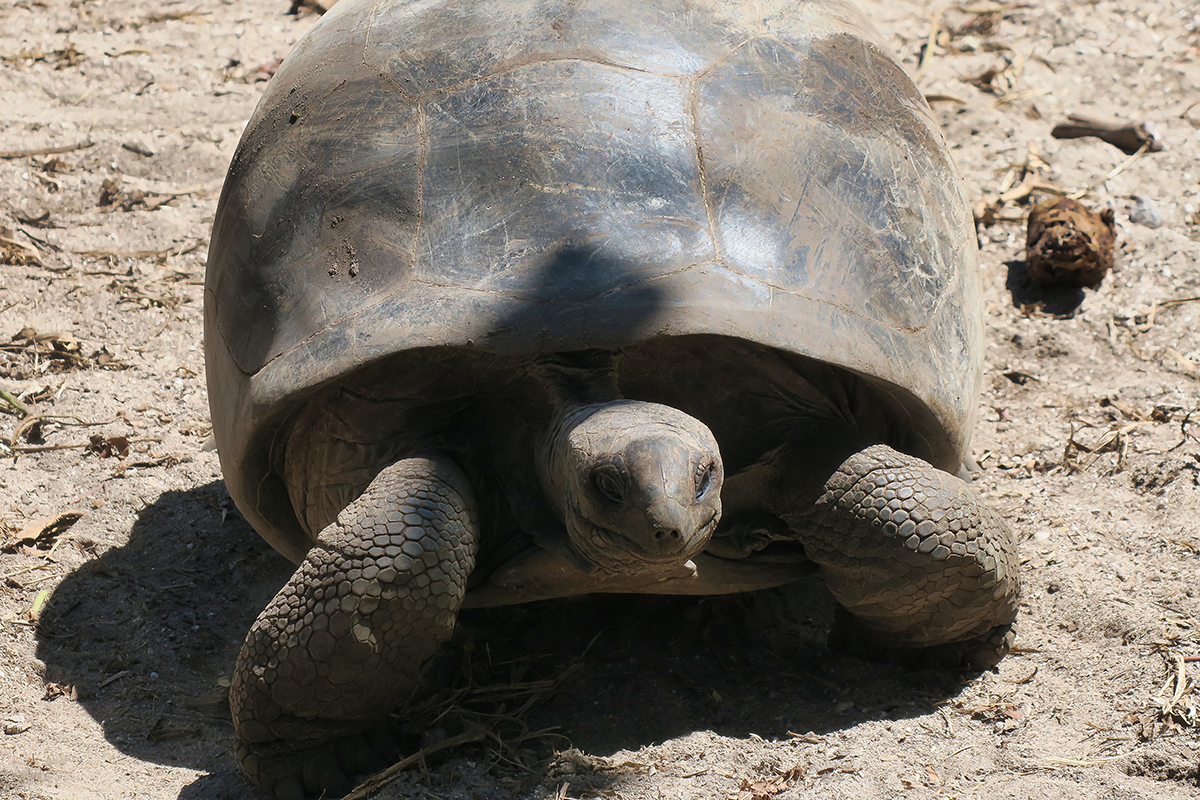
[205,0,1019,798]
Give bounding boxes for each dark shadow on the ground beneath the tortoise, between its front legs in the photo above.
[458,578,984,756]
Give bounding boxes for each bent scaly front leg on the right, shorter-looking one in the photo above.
[779,434,1020,669]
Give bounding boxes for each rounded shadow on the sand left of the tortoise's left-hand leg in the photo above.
[36,481,293,798]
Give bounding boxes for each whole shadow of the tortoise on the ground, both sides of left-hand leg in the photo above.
[37,481,961,799]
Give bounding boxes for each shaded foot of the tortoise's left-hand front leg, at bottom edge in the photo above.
[236,728,400,800]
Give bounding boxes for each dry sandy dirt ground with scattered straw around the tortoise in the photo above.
[0,0,1200,800]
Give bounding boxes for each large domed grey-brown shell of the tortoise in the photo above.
[205,0,982,557]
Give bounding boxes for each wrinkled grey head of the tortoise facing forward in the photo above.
[539,399,724,572]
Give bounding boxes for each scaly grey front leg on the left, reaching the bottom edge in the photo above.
[229,458,478,800]
